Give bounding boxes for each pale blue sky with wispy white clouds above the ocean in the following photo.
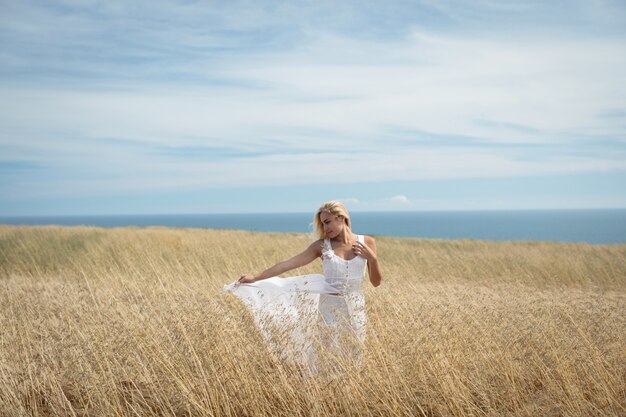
[0,0,626,216]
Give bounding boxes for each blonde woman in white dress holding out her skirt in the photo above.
[224,201,382,375]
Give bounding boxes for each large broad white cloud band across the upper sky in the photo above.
[0,28,626,148]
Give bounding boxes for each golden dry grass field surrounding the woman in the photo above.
[0,225,626,417]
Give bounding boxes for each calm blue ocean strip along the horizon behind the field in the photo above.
[0,209,626,244]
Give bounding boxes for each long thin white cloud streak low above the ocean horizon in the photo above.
[3,143,626,197]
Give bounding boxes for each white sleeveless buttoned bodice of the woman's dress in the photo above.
[322,235,367,293]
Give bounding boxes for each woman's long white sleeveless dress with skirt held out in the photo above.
[223,235,367,375]
